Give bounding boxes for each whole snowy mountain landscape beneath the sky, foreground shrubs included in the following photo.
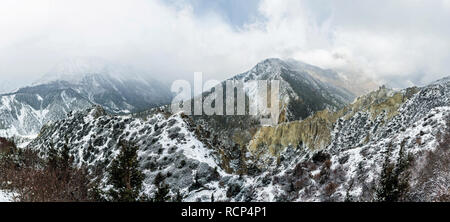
[0,59,450,202]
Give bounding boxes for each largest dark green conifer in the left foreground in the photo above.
[109,141,144,202]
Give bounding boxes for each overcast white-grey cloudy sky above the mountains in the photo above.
[0,0,450,91]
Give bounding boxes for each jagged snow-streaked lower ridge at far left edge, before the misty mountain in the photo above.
[0,84,92,137]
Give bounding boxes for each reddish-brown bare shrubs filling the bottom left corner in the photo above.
[0,143,92,202]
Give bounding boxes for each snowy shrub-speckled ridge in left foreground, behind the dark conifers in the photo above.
[29,107,226,199]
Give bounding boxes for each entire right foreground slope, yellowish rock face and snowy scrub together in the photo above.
[243,77,450,201]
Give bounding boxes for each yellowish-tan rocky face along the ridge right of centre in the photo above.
[249,87,417,162]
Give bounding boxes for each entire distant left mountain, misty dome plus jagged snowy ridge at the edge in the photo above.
[0,59,172,140]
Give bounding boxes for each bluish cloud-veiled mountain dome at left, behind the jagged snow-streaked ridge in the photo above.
[35,58,172,114]
